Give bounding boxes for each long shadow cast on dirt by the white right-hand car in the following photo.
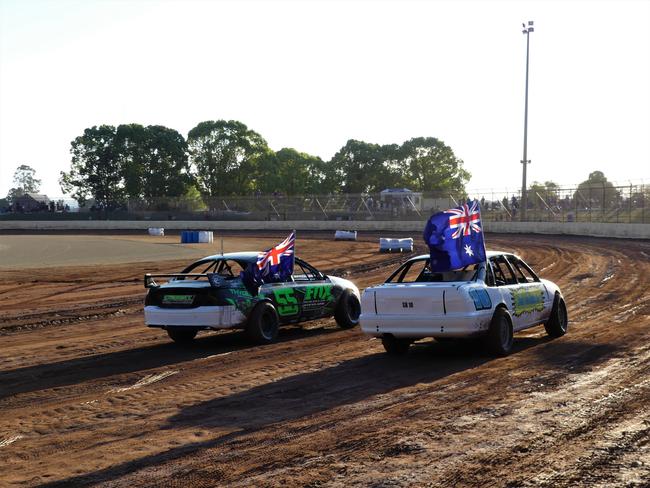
[39,337,584,487]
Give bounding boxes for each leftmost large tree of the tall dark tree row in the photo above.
[59,125,125,208]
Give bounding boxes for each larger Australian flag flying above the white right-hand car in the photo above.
[423,200,485,271]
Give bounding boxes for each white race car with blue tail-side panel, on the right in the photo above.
[359,251,568,355]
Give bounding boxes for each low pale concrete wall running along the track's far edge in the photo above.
[0,220,650,239]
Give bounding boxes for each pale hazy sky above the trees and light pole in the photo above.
[0,0,650,196]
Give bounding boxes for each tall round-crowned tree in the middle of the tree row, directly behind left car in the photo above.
[187,120,269,197]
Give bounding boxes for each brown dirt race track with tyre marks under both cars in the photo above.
[0,233,650,487]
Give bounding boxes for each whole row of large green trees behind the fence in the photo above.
[59,120,470,207]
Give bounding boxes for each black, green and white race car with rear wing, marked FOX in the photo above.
[144,252,361,344]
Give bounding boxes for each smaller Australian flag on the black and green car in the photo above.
[240,230,296,295]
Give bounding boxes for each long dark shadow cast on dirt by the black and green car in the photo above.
[0,327,340,400]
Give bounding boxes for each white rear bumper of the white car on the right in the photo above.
[359,310,493,339]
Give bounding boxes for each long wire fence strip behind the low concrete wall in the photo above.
[0,184,650,223]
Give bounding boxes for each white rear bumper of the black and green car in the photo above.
[144,305,246,329]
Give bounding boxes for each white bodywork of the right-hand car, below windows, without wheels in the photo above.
[359,253,560,339]
